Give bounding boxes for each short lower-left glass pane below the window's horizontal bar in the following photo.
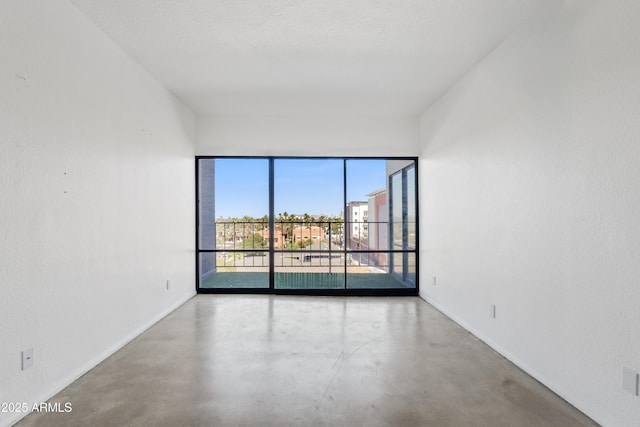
[199,252,269,288]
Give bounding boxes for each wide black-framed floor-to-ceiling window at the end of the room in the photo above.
[196,157,418,295]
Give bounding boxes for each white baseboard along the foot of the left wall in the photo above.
[0,292,196,427]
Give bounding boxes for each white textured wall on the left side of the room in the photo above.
[0,0,195,426]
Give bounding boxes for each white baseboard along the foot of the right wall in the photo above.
[419,294,603,425]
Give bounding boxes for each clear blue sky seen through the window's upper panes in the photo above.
[215,159,386,218]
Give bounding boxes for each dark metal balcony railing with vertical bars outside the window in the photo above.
[200,221,415,287]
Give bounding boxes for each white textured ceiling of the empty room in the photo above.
[71,0,559,116]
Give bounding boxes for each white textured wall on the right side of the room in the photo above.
[420,0,640,427]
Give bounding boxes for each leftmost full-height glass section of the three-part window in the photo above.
[198,159,269,288]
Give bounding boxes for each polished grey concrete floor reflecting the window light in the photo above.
[19,295,596,427]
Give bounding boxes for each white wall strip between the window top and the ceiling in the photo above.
[196,117,419,156]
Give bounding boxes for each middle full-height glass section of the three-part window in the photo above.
[274,159,344,289]
